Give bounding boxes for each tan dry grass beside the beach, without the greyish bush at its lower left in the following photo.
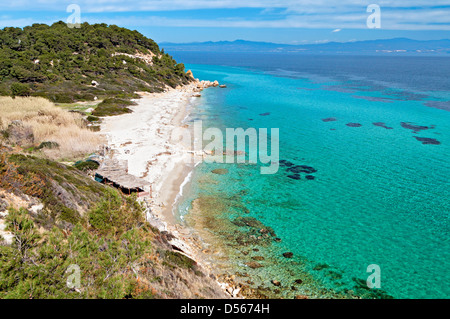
[0,97,103,159]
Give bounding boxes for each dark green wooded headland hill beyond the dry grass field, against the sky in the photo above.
[0,21,190,103]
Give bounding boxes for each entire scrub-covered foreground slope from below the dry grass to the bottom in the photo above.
[0,148,223,299]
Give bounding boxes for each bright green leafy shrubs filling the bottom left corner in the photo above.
[0,209,152,299]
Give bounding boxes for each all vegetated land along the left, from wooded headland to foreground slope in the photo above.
[0,22,224,299]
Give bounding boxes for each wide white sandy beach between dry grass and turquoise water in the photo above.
[101,84,200,224]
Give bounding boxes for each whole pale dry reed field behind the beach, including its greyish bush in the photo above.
[0,97,103,160]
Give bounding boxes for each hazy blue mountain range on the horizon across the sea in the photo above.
[160,38,450,55]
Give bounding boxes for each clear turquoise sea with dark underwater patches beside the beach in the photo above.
[175,52,450,298]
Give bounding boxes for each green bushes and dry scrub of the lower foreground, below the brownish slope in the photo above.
[0,189,224,299]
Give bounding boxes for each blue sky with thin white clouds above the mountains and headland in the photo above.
[0,0,450,44]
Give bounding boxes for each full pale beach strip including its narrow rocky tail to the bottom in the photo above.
[99,81,240,298]
